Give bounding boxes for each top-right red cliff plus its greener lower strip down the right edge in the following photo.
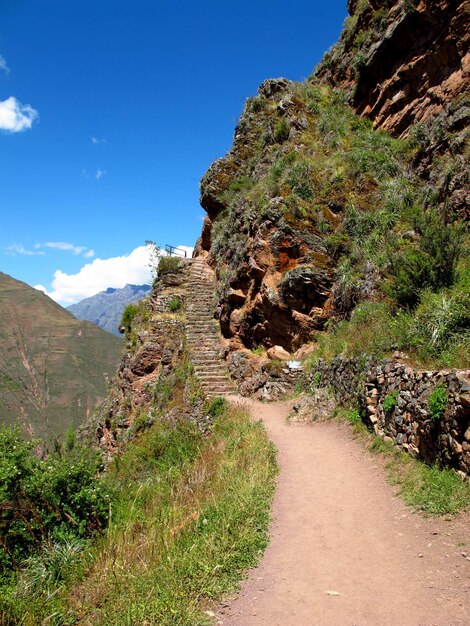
[314,0,470,219]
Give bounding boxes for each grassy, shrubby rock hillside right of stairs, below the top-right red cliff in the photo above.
[200,79,469,366]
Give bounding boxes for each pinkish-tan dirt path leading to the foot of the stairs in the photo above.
[217,401,470,626]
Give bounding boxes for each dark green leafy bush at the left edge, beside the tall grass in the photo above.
[0,428,110,574]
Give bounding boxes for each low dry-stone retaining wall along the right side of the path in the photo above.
[308,356,470,476]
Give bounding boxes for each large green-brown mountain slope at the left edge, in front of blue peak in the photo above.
[0,272,122,439]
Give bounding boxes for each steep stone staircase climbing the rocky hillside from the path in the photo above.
[186,258,235,397]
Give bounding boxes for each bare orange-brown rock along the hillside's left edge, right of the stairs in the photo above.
[196,78,337,351]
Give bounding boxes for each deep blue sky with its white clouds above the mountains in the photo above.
[0,0,346,304]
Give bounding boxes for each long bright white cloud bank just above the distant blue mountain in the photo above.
[36,246,193,306]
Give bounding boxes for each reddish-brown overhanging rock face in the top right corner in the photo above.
[315,0,470,134]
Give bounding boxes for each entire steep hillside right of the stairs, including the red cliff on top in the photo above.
[196,0,469,366]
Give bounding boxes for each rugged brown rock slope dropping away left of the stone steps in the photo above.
[90,264,188,459]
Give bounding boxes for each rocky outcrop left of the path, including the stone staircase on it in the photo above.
[81,259,234,460]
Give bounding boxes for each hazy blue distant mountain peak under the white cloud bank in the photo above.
[67,285,151,336]
